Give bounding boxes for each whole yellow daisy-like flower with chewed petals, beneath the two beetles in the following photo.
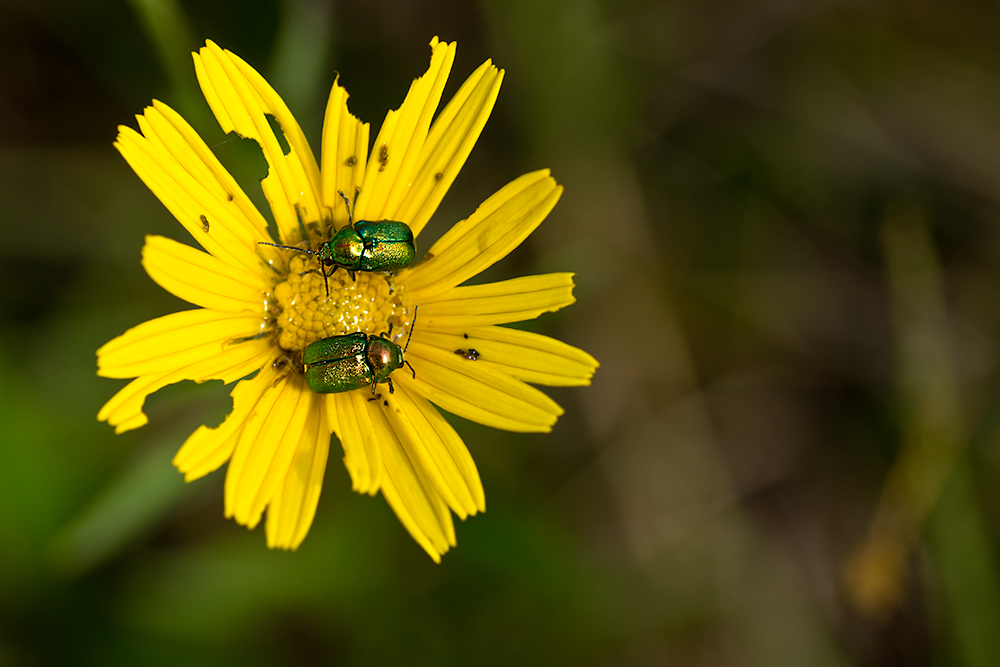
[97,38,598,561]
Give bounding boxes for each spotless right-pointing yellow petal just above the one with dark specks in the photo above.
[414,273,576,332]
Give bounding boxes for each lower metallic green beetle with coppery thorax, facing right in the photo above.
[302,308,417,396]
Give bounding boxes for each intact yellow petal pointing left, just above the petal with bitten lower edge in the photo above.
[97,308,263,382]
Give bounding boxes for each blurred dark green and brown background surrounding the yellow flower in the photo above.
[0,0,1000,666]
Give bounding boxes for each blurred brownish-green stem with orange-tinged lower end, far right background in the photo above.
[845,206,965,617]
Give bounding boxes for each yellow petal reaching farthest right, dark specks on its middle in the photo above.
[420,324,600,387]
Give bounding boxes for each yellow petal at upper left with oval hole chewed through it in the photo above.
[199,41,326,245]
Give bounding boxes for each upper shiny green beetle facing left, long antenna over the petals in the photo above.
[260,191,417,296]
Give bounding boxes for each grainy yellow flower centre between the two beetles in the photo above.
[274,255,409,352]
